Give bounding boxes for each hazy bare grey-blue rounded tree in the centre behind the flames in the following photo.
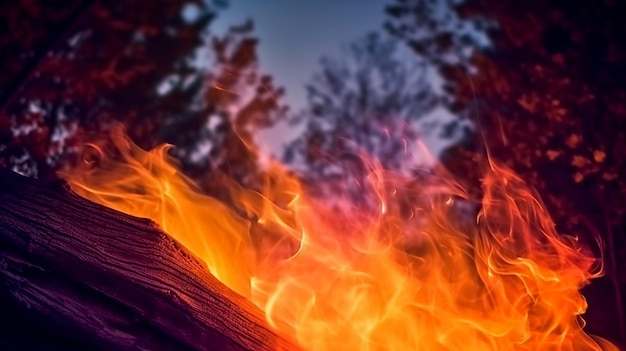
[285,33,437,195]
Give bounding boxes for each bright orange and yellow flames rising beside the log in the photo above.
[64,128,616,351]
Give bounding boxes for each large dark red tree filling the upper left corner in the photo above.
[0,0,224,177]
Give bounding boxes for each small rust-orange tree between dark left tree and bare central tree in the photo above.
[162,20,287,190]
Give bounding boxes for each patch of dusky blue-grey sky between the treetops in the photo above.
[211,0,390,111]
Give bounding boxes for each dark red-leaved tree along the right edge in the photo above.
[388,0,626,342]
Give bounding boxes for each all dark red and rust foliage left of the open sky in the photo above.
[0,0,281,187]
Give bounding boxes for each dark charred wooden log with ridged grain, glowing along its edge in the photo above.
[0,169,297,351]
